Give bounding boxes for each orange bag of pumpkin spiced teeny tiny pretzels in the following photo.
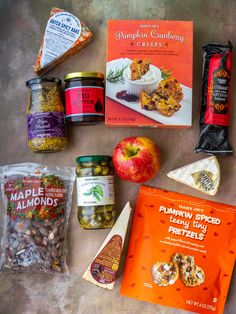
[121,186,236,313]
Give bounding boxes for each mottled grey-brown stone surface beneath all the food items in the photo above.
[0,0,236,314]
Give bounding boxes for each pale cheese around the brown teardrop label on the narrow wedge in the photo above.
[83,202,132,290]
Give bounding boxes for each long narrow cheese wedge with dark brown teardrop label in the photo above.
[83,202,132,290]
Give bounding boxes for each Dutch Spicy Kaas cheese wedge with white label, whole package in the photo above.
[34,8,92,74]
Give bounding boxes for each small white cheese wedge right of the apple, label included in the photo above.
[167,156,220,195]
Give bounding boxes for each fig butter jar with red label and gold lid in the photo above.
[64,72,105,125]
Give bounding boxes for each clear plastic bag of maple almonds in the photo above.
[0,163,75,274]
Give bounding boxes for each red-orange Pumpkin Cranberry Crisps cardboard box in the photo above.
[105,20,193,128]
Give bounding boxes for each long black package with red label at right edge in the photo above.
[195,41,233,156]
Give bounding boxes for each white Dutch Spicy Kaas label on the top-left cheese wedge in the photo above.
[40,12,81,67]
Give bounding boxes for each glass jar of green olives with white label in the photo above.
[76,155,116,229]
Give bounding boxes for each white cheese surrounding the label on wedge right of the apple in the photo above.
[167,156,220,195]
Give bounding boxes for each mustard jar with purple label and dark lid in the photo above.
[26,77,67,153]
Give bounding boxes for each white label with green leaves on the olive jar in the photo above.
[77,176,115,206]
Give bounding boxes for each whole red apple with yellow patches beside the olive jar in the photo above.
[112,136,160,183]
